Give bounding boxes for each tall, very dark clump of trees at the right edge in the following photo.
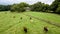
[50,0,60,14]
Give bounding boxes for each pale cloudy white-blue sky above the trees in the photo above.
[0,0,54,5]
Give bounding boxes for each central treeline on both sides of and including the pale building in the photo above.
[11,2,49,12]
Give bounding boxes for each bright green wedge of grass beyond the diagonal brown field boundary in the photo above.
[25,12,60,23]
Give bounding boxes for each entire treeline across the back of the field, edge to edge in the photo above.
[0,0,60,14]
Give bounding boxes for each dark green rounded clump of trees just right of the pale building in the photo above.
[31,2,49,12]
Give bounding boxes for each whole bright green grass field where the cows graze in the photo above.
[0,11,60,34]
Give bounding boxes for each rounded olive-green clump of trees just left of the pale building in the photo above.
[11,2,29,12]
